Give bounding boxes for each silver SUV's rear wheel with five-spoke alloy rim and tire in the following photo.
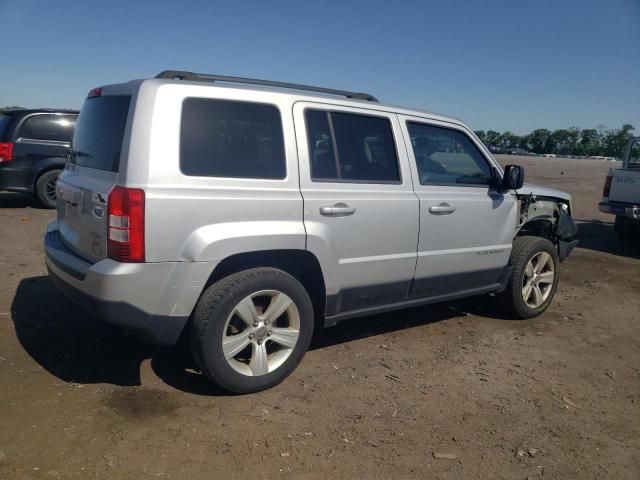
[191,268,314,393]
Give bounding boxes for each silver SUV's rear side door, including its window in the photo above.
[294,102,418,316]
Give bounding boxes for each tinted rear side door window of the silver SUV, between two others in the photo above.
[305,110,400,183]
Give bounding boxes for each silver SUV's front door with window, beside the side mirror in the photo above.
[400,116,517,297]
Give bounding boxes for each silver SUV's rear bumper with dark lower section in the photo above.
[44,224,212,345]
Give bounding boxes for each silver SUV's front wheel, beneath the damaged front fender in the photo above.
[498,236,560,319]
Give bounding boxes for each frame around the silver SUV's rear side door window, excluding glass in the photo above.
[302,108,404,185]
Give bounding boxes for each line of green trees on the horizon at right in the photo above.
[475,123,635,158]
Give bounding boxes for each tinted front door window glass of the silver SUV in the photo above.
[407,122,491,185]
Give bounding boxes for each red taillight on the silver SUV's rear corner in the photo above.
[107,187,144,262]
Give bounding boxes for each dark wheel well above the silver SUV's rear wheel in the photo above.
[205,250,326,325]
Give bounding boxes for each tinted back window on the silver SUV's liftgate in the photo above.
[70,95,131,172]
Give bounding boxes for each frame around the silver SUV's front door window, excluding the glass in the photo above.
[401,115,502,191]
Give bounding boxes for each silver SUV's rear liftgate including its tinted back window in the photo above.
[57,95,131,261]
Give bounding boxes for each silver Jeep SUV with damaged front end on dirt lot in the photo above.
[45,71,576,393]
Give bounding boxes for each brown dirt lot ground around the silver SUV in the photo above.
[0,157,640,479]
